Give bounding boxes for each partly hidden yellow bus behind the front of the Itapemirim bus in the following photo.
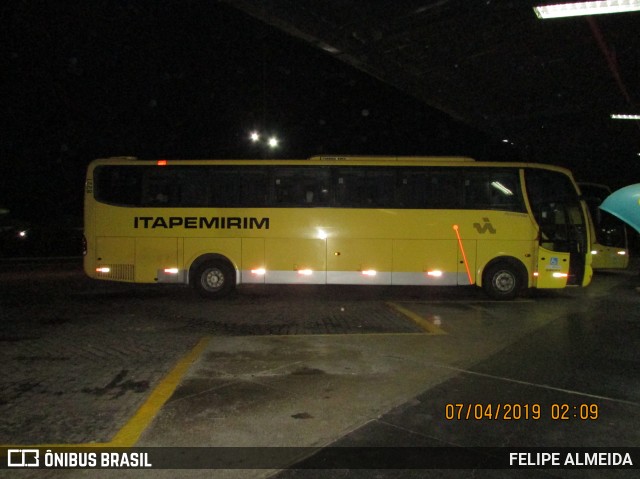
[578,183,629,269]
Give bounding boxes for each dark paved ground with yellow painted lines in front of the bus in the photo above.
[0,261,640,478]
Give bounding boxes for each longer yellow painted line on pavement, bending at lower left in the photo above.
[0,337,210,448]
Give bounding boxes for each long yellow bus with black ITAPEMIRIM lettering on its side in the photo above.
[84,156,592,299]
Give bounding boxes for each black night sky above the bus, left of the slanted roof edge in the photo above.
[0,0,511,223]
